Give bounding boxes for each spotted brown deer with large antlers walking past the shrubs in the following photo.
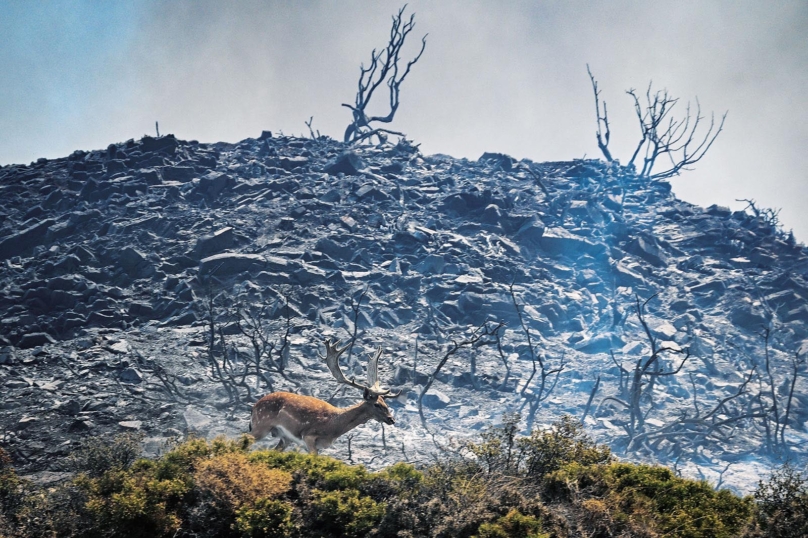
[250,339,401,454]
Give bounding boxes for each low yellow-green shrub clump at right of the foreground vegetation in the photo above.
[547,463,752,538]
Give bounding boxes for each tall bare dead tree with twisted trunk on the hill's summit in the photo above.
[342,4,426,143]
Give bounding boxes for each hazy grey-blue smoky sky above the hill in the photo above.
[0,0,808,242]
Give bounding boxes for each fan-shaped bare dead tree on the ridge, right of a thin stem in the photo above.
[626,83,727,179]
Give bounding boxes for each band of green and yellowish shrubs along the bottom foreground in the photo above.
[0,415,772,538]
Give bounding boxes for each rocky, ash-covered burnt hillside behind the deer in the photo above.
[0,132,808,489]
